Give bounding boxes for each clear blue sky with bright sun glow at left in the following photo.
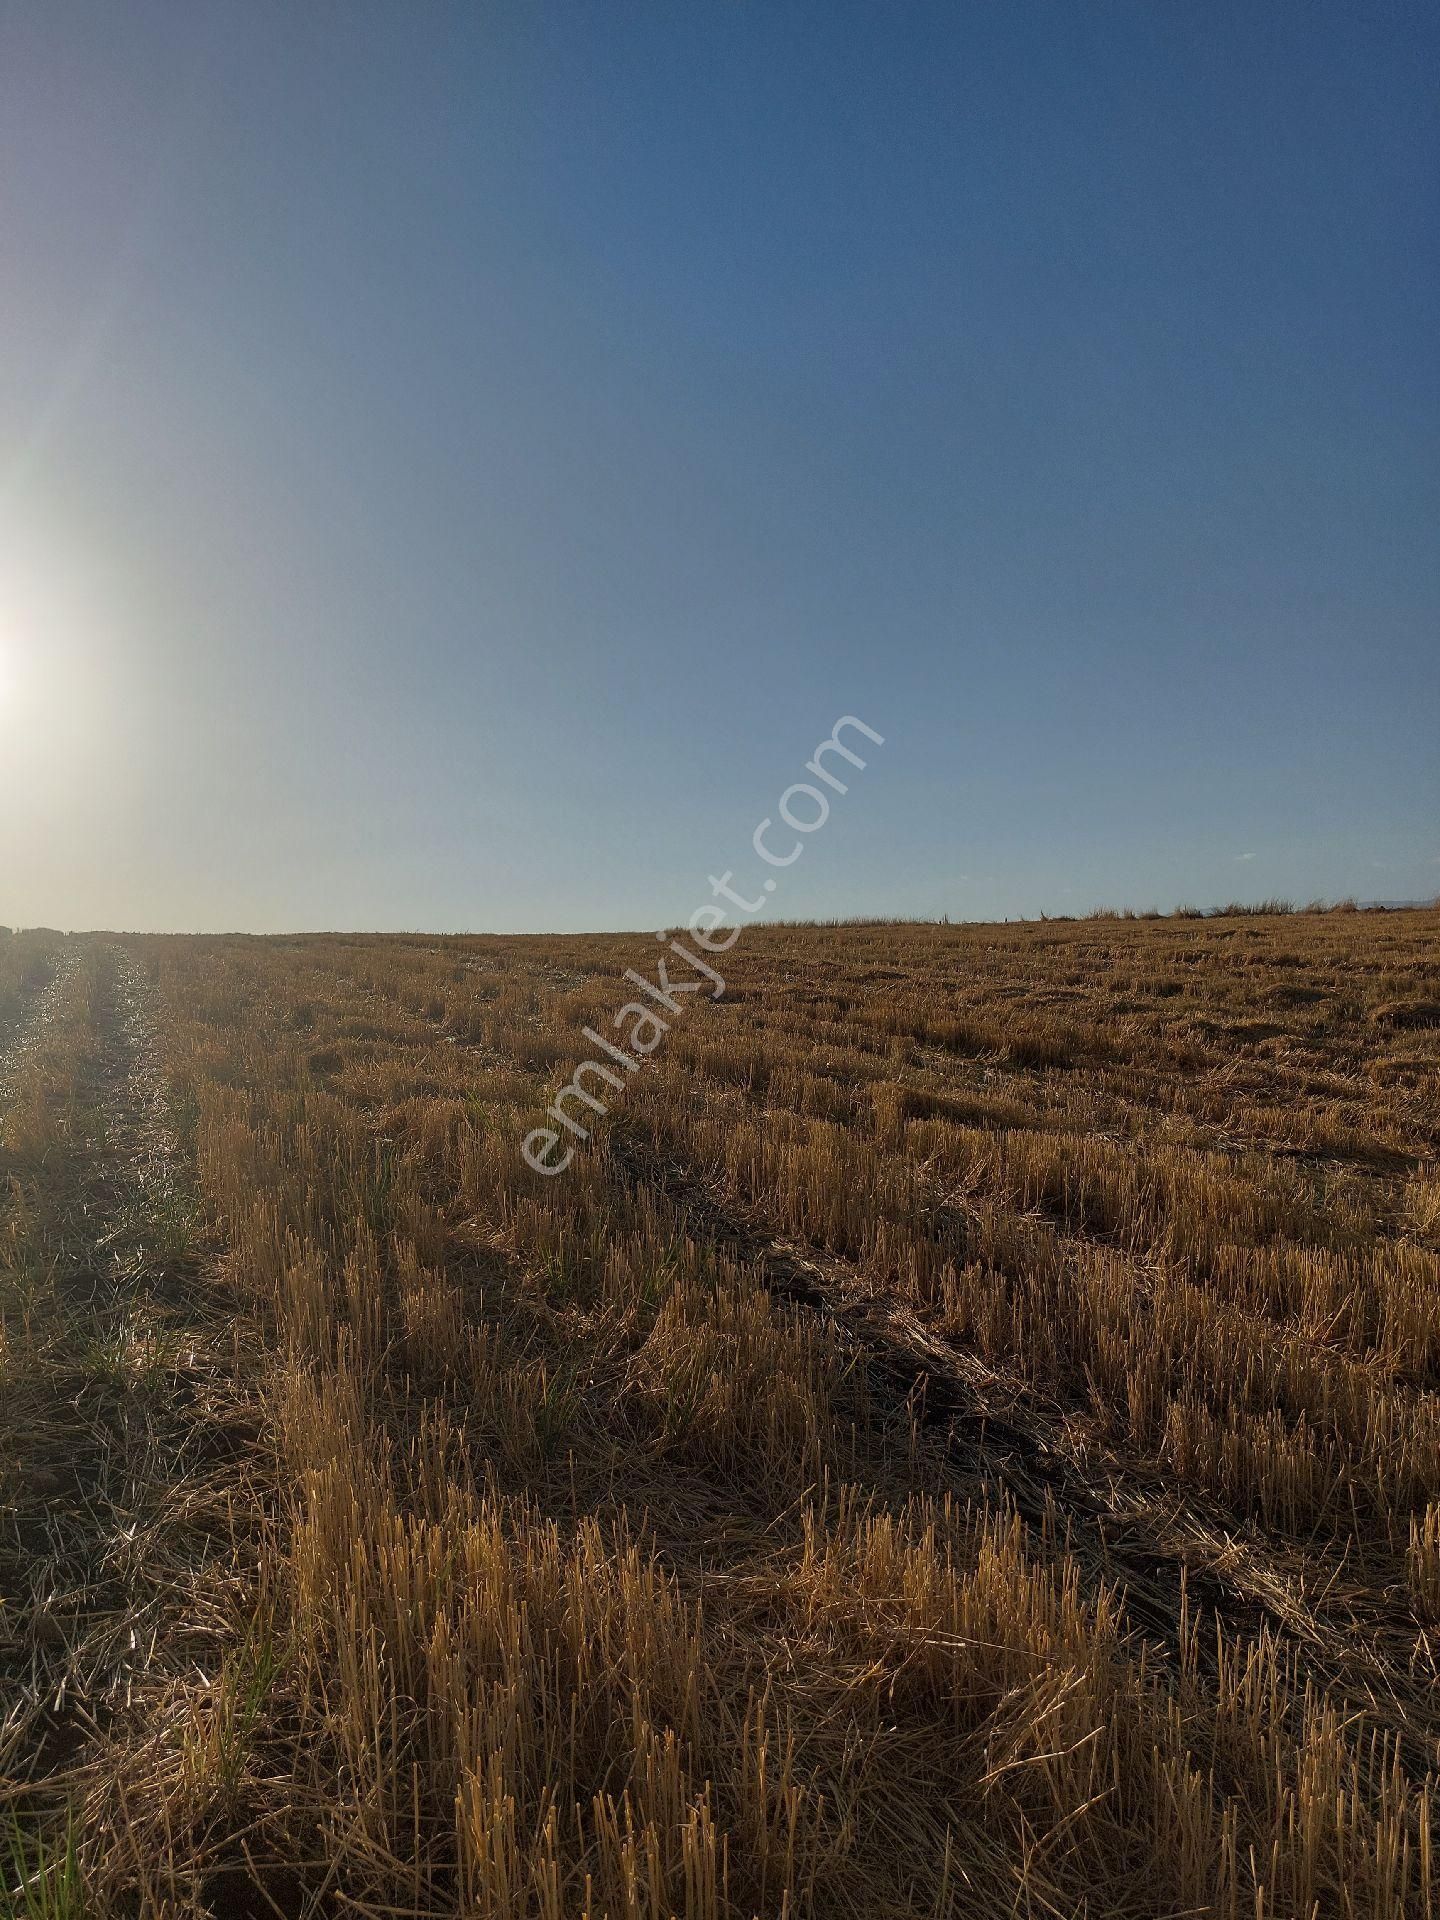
[0,0,1440,931]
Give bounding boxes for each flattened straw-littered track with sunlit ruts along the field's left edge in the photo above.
[0,945,253,1866]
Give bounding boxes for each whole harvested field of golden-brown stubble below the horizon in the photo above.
[0,910,1440,1920]
